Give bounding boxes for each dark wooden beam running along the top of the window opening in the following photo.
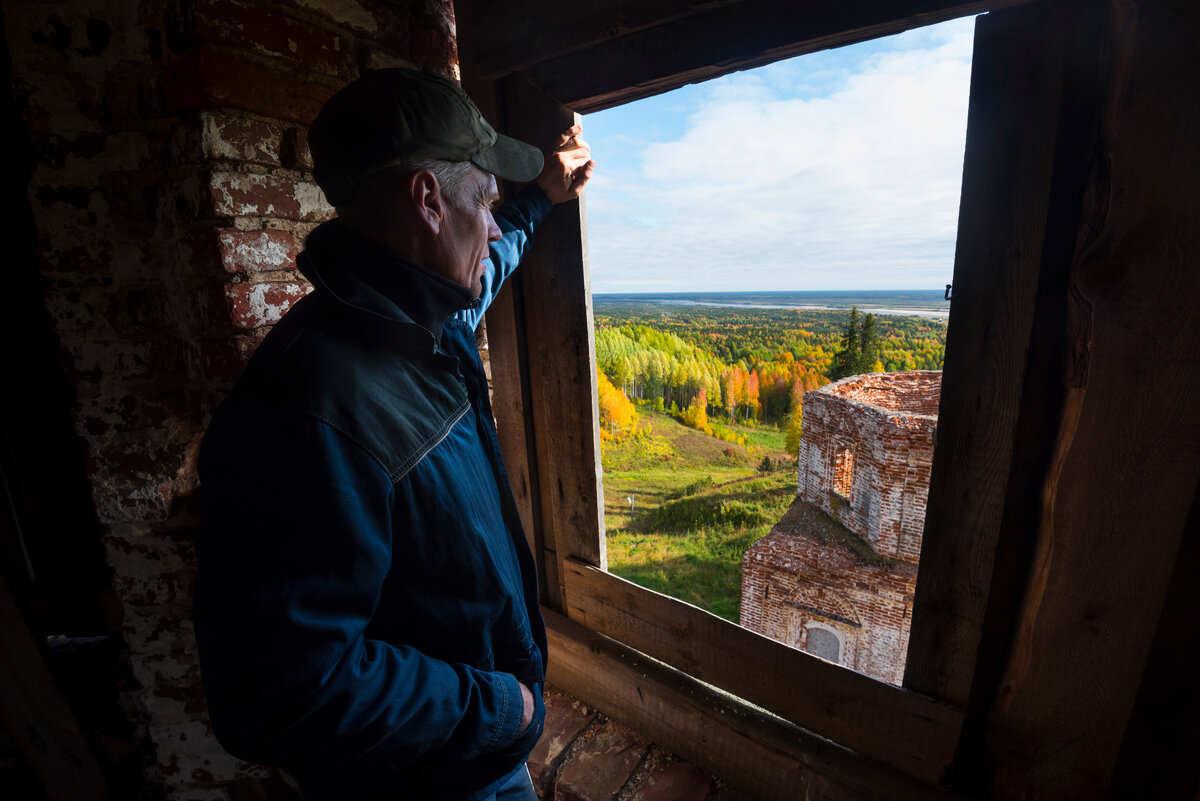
[520,0,1028,113]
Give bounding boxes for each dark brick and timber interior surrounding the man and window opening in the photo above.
[0,0,1200,801]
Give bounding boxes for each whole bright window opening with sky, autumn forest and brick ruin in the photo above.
[584,19,973,683]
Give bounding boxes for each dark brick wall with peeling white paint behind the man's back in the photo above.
[2,0,457,801]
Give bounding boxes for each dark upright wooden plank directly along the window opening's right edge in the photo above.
[905,6,1062,707]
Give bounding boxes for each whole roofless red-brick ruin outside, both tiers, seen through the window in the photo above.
[742,371,942,685]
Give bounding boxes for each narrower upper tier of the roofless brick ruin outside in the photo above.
[798,371,942,564]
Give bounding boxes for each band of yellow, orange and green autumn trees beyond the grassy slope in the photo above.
[595,305,946,448]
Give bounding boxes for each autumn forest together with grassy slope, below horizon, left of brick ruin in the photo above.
[594,301,946,621]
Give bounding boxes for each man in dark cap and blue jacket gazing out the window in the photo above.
[194,70,594,801]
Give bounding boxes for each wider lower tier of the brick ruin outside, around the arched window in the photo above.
[740,510,917,685]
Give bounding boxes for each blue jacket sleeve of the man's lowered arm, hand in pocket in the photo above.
[194,402,522,767]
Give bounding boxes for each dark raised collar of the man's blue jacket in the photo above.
[296,219,479,344]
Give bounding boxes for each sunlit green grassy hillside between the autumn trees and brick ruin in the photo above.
[604,408,796,622]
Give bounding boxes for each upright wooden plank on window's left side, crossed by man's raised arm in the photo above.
[502,79,605,606]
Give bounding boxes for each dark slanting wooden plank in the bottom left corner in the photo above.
[0,568,108,801]
